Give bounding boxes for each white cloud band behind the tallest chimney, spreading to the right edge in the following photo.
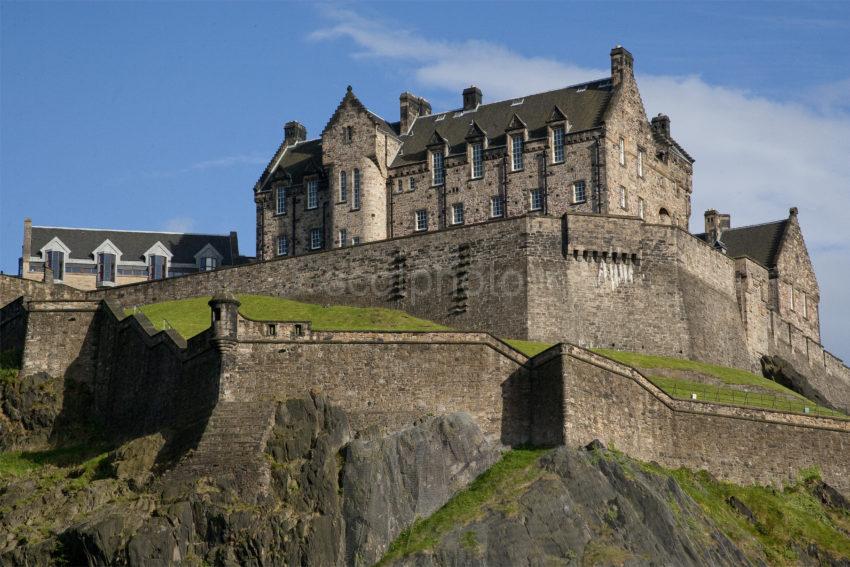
[310,9,850,358]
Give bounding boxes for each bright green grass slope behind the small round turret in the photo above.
[127,295,448,338]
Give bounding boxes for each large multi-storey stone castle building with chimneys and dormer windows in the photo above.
[254,47,693,259]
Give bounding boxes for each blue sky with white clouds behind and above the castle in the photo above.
[0,2,850,358]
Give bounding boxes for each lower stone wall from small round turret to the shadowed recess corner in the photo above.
[221,326,530,444]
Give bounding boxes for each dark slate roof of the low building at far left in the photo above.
[31,226,235,265]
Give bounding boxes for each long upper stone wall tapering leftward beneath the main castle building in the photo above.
[90,218,528,337]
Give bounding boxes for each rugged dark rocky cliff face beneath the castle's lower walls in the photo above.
[0,396,850,567]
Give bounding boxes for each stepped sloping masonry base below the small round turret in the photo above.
[162,402,277,495]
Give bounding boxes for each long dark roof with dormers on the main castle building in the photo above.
[392,77,613,167]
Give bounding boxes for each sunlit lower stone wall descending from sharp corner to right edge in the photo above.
[538,346,850,494]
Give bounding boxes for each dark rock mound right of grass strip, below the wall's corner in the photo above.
[394,448,750,567]
